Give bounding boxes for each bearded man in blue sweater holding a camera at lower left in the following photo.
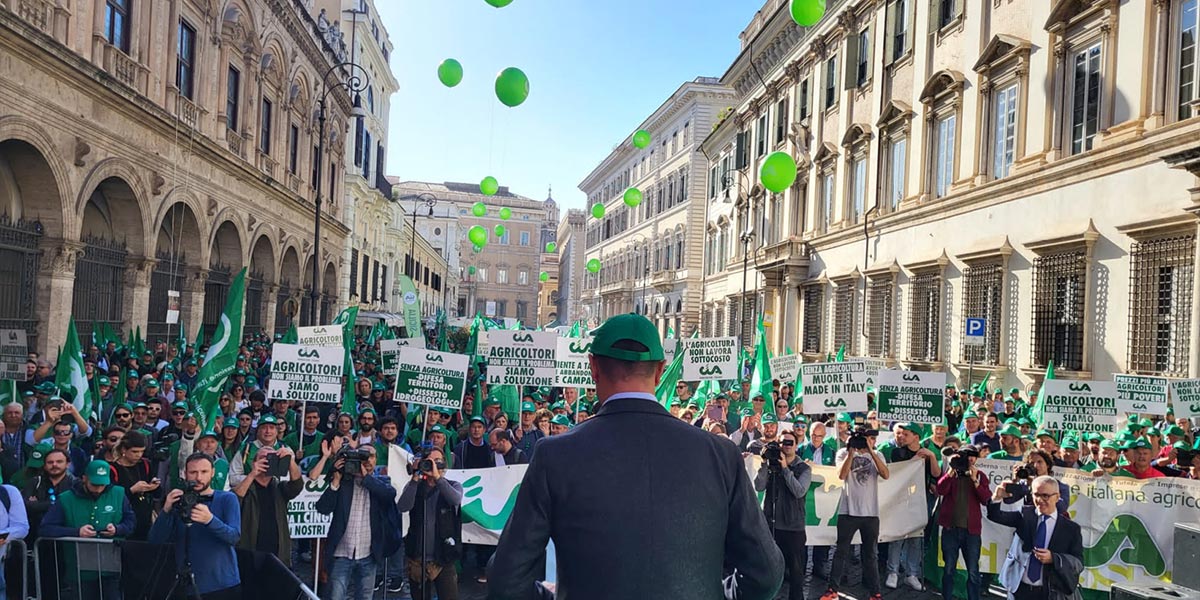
[150,452,241,600]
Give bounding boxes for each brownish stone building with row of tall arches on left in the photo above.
[0,0,352,353]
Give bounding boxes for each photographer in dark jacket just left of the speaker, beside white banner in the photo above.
[396,448,462,600]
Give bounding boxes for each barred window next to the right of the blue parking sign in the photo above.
[1032,248,1087,371]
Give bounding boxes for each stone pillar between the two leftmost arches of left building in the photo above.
[32,240,83,360]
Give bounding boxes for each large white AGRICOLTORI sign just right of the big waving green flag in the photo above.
[268,343,346,404]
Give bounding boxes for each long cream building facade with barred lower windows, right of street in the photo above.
[703,0,1200,388]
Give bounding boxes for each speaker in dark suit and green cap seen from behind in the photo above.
[488,314,784,600]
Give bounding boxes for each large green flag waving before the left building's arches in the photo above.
[188,268,246,431]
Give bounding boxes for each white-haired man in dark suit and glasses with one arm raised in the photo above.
[988,475,1084,600]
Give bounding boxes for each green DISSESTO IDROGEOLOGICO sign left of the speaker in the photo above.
[395,346,469,409]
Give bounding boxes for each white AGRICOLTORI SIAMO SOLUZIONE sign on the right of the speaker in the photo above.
[1042,379,1118,433]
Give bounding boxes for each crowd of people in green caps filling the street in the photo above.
[0,324,1200,600]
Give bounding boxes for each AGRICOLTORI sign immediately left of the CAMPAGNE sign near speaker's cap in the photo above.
[487,330,558,388]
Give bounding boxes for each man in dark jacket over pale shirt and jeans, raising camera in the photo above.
[316,438,400,600]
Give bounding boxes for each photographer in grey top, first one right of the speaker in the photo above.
[754,429,812,600]
